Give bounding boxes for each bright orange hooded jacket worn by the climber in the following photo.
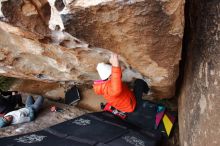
[93,66,136,112]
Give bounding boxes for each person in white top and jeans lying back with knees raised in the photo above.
[0,96,44,127]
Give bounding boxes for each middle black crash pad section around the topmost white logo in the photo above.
[50,114,127,142]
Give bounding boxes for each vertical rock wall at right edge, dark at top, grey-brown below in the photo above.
[179,0,220,146]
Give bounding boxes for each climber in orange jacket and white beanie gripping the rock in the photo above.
[93,54,149,118]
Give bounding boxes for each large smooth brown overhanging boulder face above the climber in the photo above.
[64,0,184,97]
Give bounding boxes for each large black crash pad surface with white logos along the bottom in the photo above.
[0,112,160,146]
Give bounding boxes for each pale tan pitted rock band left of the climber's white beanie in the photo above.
[0,22,109,83]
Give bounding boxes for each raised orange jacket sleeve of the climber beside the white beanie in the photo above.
[107,66,122,97]
